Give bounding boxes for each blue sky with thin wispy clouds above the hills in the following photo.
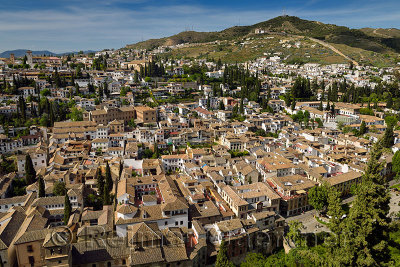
[0,0,400,52]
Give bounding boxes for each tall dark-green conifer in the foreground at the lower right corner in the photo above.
[338,141,390,266]
